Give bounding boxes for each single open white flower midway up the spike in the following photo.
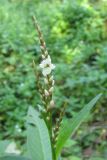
[40,55,55,76]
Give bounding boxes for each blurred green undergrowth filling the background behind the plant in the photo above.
[0,0,107,160]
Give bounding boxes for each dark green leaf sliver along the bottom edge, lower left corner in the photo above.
[0,155,31,160]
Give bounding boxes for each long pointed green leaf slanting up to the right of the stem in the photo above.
[56,94,101,157]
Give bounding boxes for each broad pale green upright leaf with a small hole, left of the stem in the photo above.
[27,107,52,160]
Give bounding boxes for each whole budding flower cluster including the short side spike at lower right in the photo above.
[33,17,64,154]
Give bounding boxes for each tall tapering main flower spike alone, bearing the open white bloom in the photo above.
[33,17,55,127]
